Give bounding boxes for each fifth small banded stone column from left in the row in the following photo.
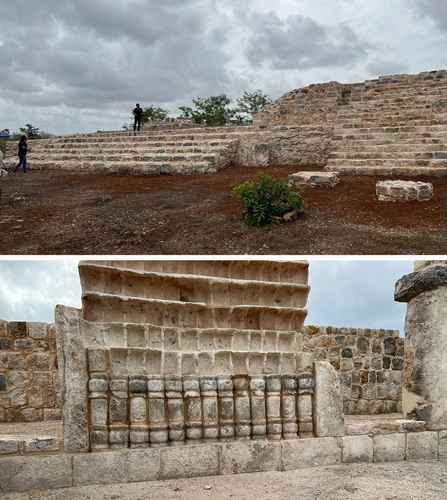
[165,376,185,445]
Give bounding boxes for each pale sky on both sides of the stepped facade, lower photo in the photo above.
[0,259,412,332]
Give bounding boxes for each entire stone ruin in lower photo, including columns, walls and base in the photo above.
[0,260,447,493]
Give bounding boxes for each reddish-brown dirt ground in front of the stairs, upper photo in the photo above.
[0,167,447,255]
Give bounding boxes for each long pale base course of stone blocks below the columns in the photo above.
[0,431,447,493]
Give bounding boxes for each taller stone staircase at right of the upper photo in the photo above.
[326,72,447,175]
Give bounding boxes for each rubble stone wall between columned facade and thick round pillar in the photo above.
[303,326,404,415]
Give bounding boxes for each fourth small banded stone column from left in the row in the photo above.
[147,376,168,446]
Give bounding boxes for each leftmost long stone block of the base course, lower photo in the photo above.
[0,455,73,493]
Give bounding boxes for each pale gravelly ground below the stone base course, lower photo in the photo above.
[2,461,447,500]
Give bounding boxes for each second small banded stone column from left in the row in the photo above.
[109,377,129,448]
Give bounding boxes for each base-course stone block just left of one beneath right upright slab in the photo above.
[220,441,281,474]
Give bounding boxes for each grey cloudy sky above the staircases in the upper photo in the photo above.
[0,0,447,133]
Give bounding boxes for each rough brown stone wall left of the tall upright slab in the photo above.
[0,321,61,422]
